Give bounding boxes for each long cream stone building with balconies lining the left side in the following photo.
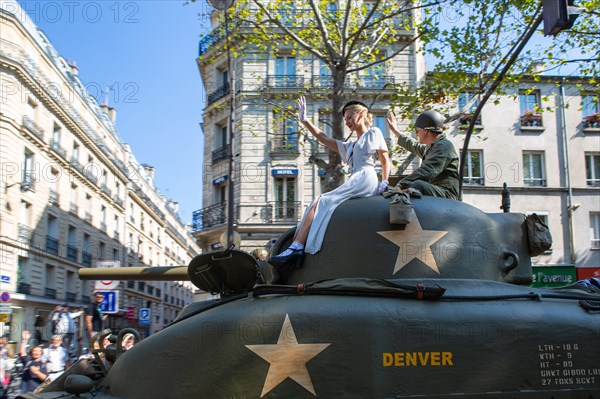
[0,2,199,341]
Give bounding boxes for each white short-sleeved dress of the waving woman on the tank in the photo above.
[298,127,388,254]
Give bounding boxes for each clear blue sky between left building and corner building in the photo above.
[19,0,210,223]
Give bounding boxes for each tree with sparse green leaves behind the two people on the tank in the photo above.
[195,0,600,194]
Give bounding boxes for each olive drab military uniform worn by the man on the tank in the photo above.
[398,133,459,199]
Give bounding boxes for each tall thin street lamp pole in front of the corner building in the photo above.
[208,0,235,247]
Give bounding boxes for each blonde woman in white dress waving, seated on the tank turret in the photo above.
[269,97,390,266]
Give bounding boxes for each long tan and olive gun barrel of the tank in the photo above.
[79,266,190,281]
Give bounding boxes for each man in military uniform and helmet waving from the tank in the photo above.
[387,111,459,199]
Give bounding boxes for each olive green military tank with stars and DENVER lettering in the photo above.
[21,197,600,399]
